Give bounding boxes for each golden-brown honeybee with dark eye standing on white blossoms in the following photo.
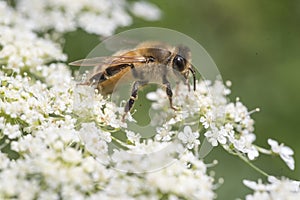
[70,42,196,120]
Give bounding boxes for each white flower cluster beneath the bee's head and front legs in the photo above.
[148,81,259,160]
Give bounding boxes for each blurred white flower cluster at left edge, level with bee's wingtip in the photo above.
[0,25,66,72]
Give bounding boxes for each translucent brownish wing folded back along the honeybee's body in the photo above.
[69,55,147,66]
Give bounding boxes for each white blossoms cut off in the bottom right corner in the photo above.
[243,176,300,200]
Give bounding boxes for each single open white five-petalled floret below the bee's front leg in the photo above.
[178,126,200,149]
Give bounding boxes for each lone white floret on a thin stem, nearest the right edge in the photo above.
[268,139,295,170]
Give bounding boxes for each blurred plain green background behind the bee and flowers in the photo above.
[65,0,300,199]
